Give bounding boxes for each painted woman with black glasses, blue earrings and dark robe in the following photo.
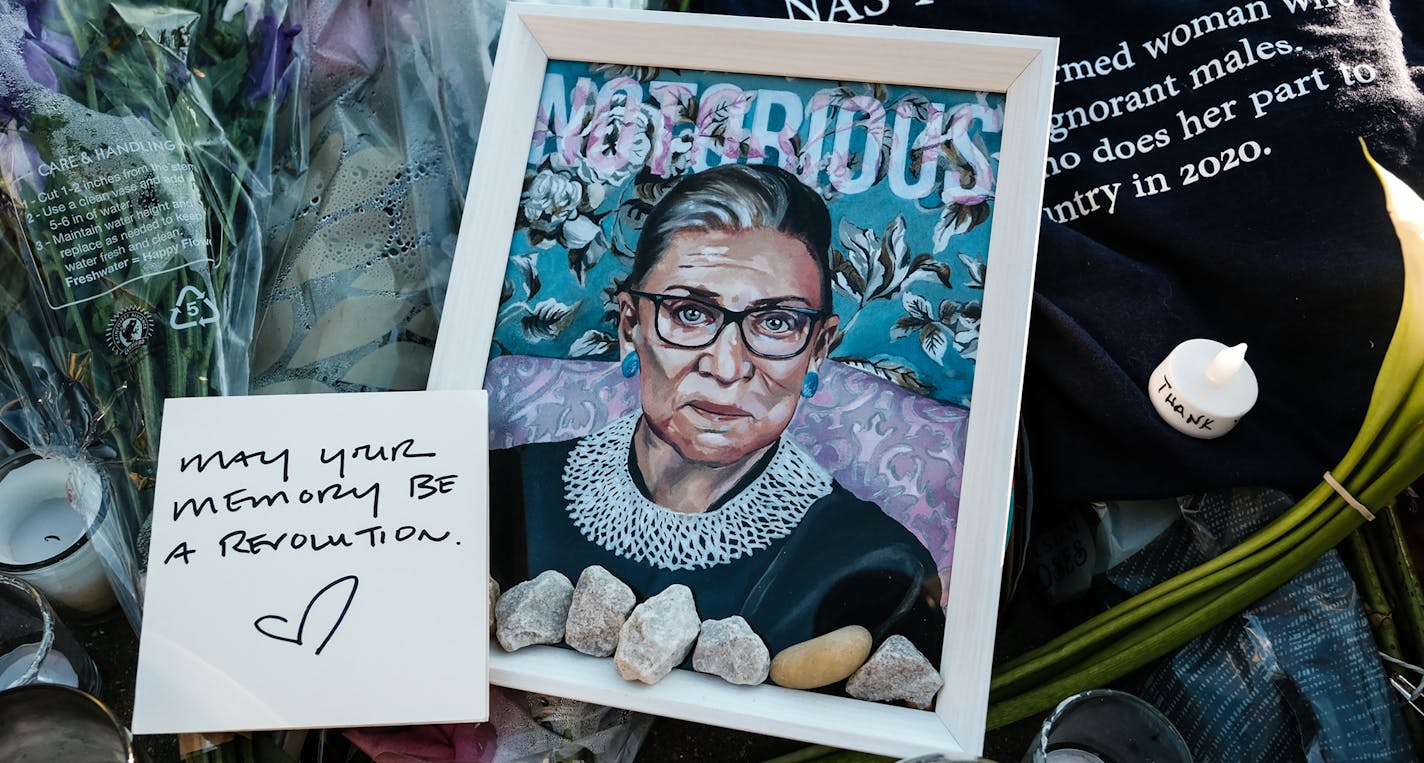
[490,164,944,662]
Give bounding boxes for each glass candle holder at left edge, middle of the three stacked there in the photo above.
[0,574,100,691]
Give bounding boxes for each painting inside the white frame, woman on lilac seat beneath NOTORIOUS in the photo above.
[484,61,1002,686]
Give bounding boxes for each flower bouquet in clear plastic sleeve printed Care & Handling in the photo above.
[0,0,300,622]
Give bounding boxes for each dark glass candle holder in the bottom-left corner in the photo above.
[0,683,148,763]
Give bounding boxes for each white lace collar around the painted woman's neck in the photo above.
[564,411,830,569]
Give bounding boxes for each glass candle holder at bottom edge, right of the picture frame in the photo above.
[1024,689,1192,763]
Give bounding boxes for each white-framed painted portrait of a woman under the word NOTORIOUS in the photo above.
[430,4,1057,757]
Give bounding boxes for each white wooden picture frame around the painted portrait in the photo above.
[429,4,1057,759]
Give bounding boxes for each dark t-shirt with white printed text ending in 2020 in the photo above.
[703,0,1424,511]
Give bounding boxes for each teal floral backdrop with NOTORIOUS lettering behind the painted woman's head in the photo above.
[493,61,1002,406]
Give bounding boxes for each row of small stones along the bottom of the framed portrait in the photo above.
[490,565,944,709]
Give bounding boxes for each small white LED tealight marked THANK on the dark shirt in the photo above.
[1148,339,1257,440]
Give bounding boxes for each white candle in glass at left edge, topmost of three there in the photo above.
[0,451,115,616]
